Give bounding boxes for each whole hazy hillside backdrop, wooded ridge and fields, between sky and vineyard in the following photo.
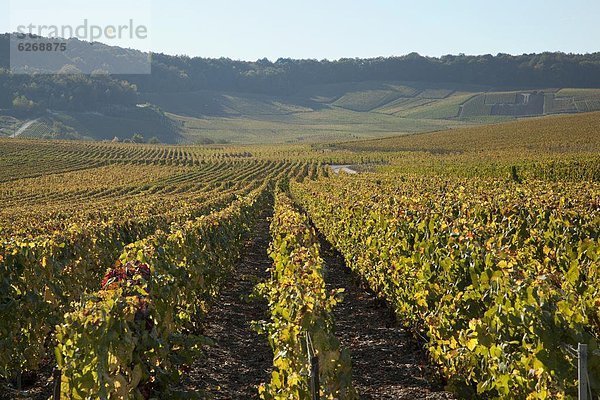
[0,35,600,143]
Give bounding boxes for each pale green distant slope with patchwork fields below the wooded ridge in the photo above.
[137,82,600,143]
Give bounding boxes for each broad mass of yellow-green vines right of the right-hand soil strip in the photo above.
[291,174,600,399]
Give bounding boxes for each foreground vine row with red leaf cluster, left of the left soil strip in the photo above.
[56,184,269,399]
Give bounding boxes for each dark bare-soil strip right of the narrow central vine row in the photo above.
[321,236,454,400]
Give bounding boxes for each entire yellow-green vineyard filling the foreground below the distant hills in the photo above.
[0,111,600,400]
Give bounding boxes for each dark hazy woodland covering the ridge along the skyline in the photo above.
[0,34,600,112]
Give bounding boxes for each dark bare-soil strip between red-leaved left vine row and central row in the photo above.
[185,219,273,400]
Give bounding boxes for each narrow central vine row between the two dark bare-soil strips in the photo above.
[258,193,357,399]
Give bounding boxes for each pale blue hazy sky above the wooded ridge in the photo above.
[0,0,600,60]
